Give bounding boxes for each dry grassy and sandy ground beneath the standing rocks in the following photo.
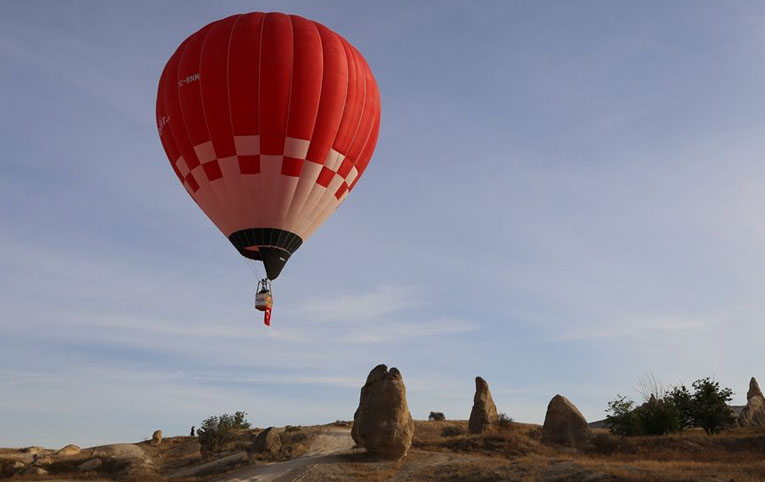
[0,421,765,482]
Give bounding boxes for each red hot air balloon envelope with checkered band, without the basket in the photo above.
[157,12,380,279]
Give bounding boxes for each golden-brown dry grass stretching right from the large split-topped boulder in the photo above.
[413,421,765,482]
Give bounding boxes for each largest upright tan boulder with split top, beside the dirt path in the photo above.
[351,365,414,460]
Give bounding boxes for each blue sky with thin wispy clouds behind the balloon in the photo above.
[0,0,765,448]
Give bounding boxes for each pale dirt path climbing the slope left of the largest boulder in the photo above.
[217,429,355,482]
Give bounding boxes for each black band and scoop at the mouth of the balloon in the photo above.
[228,228,303,280]
